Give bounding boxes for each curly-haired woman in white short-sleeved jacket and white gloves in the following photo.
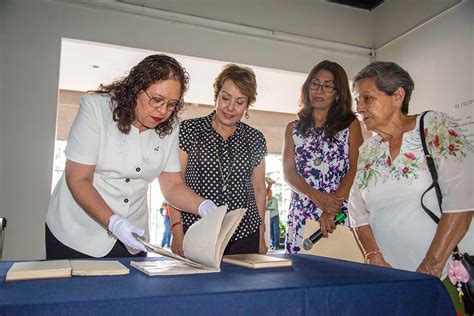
[45,55,216,259]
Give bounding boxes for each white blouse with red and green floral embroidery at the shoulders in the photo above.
[349,112,474,271]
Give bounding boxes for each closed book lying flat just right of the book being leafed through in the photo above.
[222,253,293,269]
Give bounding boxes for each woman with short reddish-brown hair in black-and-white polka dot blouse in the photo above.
[170,64,267,255]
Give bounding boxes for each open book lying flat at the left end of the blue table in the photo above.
[5,259,130,281]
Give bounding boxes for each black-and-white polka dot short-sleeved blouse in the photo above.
[179,112,267,240]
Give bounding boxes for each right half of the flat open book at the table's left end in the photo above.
[70,259,130,276]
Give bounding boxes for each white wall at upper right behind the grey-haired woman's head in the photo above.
[376,0,474,121]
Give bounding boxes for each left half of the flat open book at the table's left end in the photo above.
[5,260,72,281]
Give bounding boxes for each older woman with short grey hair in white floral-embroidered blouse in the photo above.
[349,62,474,314]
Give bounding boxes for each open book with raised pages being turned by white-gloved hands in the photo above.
[131,205,246,276]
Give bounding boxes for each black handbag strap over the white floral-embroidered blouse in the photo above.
[420,111,459,253]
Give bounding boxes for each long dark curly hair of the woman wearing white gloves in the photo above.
[95,54,189,137]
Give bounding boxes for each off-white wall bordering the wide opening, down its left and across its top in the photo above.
[0,0,369,259]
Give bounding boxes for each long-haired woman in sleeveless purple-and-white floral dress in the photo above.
[283,60,362,253]
